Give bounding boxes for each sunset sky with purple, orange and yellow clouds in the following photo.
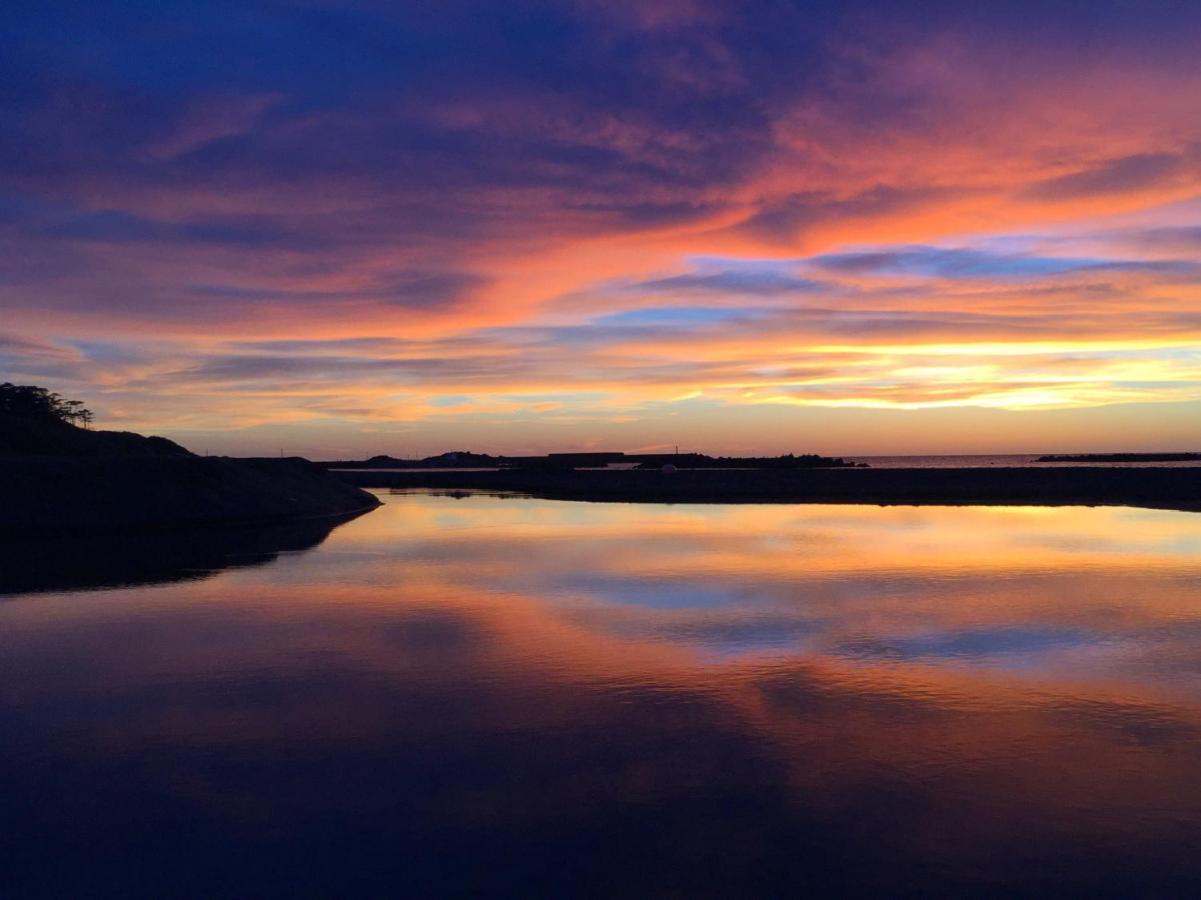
[0,0,1201,458]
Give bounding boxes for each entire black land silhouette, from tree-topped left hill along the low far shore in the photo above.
[9,374,1201,531]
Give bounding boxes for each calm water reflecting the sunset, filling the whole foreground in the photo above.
[7,494,1201,898]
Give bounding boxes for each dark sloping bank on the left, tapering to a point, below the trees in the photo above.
[0,417,378,536]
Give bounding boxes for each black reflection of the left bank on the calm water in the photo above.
[0,512,364,596]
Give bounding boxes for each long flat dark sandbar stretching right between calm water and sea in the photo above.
[336,466,1201,511]
